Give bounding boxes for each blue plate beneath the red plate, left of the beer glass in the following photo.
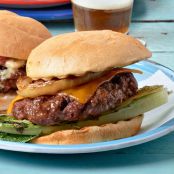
[0,5,72,21]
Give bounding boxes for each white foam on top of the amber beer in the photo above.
[71,0,133,10]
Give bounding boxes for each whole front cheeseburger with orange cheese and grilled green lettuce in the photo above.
[5,30,167,144]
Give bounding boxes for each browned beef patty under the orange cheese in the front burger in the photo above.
[12,73,138,125]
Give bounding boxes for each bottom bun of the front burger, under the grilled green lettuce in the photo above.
[32,115,143,145]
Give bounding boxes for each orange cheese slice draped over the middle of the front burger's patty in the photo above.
[61,68,142,104]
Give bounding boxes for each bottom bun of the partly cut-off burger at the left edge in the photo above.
[0,92,17,114]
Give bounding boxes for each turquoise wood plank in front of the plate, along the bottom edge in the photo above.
[0,144,174,174]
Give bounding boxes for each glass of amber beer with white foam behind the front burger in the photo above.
[71,0,133,33]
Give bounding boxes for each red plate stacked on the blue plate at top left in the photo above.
[0,0,70,5]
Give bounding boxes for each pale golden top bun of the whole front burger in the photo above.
[27,30,151,80]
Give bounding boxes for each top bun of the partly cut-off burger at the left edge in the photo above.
[0,10,51,60]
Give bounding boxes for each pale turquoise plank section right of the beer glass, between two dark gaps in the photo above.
[130,22,174,52]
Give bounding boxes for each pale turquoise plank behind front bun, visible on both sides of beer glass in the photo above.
[45,22,174,52]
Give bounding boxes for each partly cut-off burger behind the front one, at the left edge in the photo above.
[0,10,51,112]
